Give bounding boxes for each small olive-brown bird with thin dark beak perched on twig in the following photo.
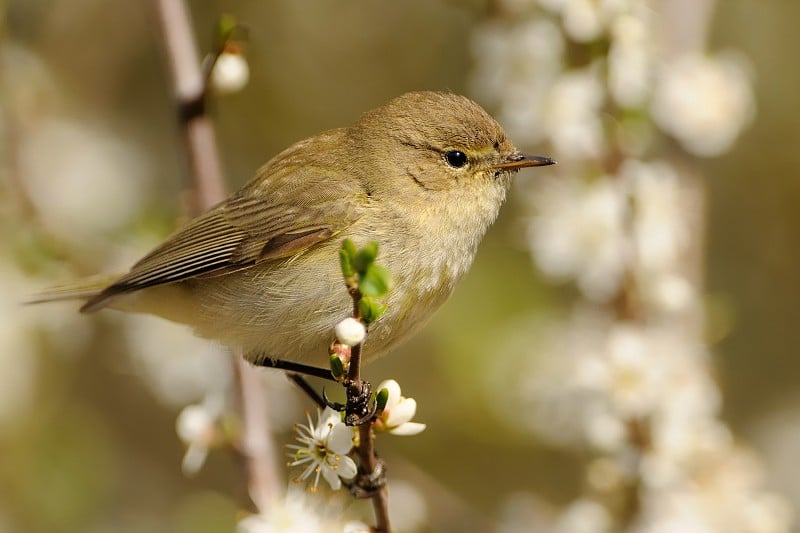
[35,92,554,364]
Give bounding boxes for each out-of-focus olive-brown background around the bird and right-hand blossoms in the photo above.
[0,0,800,532]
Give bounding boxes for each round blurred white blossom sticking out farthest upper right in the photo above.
[652,53,755,156]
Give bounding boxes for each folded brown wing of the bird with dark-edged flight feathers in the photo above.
[81,139,366,312]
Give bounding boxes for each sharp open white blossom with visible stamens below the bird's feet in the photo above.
[287,407,356,492]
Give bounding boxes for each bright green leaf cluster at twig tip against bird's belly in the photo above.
[339,239,392,324]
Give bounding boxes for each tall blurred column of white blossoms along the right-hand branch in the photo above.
[473,0,793,533]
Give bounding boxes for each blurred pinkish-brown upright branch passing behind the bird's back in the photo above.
[155,0,279,512]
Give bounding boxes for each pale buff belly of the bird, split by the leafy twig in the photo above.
[122,233,472,366]
